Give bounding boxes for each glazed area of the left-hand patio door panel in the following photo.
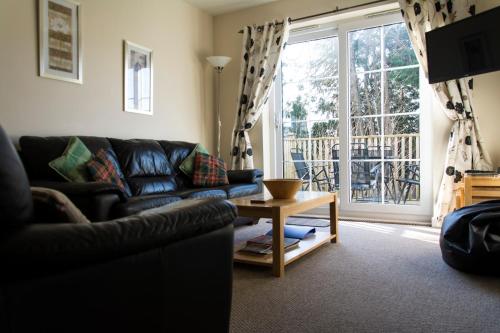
[280,30,339,192]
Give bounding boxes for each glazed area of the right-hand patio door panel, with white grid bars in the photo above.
[347,23,420,205]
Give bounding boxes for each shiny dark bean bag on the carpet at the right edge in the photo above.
[439,200,500,275]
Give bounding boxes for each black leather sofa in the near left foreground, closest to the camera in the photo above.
[0,127,236,333]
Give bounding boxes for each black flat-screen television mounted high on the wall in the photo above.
[425,7,500,83]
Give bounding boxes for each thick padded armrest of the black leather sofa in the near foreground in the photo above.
[0,199,236,281]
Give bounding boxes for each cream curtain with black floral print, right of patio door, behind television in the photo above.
[399,0,491,227]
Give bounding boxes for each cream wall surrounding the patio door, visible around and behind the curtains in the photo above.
[214,0,500,213]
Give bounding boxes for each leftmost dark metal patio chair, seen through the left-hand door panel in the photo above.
[290,148,334,192]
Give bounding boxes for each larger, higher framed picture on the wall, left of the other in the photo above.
[38,0,83,84]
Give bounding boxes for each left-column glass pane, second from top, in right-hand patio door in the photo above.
[349,73,380,116]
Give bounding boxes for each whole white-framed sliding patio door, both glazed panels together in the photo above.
[275,15,431,219]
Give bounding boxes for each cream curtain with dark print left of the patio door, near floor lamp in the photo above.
[231,19,289,170]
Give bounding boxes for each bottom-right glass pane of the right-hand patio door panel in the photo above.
[384,161,420,205]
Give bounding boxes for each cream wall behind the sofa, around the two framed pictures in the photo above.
[0,0,214,148]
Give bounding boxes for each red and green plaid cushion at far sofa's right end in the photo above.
[193,153,229,187]
